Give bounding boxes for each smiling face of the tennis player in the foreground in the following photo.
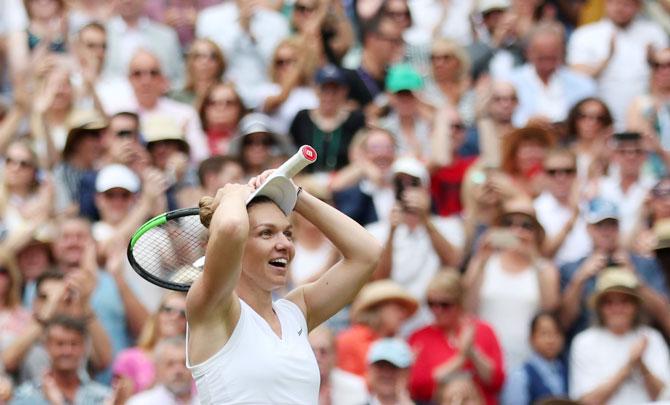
[242,202,295,291]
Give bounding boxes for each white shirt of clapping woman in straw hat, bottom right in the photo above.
[569,326,670,405]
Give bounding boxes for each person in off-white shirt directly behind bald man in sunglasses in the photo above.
[106,0,184,87]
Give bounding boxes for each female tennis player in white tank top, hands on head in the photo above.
[187,171,381,404]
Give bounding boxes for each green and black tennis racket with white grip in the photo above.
[127,145,316,291]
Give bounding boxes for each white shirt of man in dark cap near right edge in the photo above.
[598,175,655,240]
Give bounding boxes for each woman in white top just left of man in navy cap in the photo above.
[259,36,318,134]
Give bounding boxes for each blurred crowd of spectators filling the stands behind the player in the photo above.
[0,0,670,405]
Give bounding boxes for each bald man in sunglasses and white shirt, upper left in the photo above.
[101,49,209,162]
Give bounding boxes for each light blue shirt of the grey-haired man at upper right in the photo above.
[508,63,596,127]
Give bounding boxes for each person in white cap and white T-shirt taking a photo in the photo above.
[367,157,463,302]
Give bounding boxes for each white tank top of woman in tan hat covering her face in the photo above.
[478,254,540,371]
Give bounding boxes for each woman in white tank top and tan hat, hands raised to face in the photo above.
[464,198,559,371]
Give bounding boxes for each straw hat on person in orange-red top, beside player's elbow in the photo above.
[351,279,419,322]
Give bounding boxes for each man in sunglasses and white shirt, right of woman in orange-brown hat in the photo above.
[533,149,591,266]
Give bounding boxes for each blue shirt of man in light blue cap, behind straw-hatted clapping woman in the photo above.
[560,254,668,340]
